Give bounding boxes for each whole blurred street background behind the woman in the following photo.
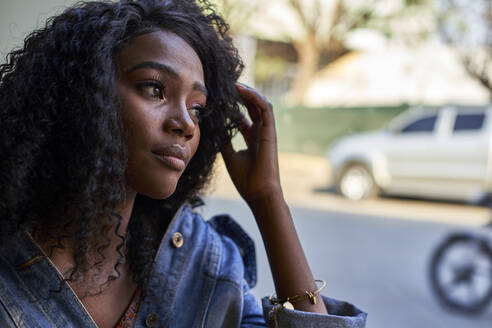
[0,0,492,328]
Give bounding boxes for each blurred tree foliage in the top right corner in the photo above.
[440,0,492,100]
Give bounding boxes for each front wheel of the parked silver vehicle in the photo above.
[337,164,378,200]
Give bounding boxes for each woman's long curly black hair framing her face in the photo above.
[0,0,243,294]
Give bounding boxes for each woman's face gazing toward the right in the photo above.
[115,31,207,199]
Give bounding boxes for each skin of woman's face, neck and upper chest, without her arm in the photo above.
[52,31,207,328]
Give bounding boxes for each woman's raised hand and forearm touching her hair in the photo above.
[222,83,327,314]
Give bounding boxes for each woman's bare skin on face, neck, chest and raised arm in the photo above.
[51,31,326,328]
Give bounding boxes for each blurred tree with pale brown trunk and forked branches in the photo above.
[250,0,431,103]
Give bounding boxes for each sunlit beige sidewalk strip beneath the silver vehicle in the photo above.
[208,153,491,226]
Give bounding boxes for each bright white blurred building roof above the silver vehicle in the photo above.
[306,42,490,106]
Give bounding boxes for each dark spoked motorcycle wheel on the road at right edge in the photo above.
[430,234,492,313]
